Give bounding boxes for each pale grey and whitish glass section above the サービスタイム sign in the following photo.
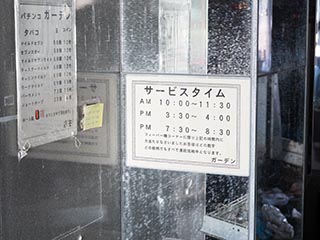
[122,0,207,73]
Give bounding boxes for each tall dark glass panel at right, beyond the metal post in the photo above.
[256,0,307,239]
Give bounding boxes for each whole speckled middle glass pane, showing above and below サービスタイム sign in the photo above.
[121,0,254,240]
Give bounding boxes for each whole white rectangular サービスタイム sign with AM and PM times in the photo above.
[126,74,251,176]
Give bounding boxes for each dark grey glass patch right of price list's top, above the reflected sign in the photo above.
[77,0,120,72]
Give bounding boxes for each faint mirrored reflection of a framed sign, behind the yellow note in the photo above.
[29,73,119,165]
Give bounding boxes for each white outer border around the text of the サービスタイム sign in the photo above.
[125,74,251,176]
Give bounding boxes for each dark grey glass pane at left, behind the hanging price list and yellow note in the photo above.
[0,0,121,240]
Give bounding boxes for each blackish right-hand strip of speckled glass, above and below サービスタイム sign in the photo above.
[204,1,254,240]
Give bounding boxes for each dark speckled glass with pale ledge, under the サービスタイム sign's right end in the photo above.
[202,175,250,240]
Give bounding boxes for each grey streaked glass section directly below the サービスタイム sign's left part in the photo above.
[123,168,205,240]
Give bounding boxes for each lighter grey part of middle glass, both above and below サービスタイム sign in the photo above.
[122,0,206,240]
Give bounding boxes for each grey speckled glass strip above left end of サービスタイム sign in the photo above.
[121,0,159,72]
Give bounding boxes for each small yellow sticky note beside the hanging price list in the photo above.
[81,103,104,130]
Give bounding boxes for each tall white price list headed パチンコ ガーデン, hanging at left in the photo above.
[16,0,77,149]
